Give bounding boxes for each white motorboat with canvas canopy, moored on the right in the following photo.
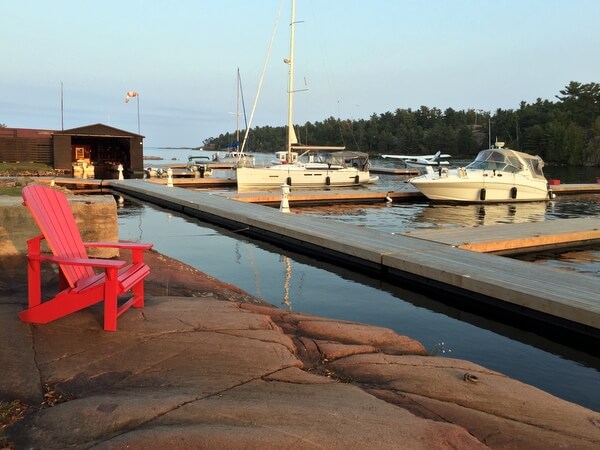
[409,142,554,203]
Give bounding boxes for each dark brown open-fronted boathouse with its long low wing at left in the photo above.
[0,123,144,178]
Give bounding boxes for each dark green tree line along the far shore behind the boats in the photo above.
[204,81,600,166]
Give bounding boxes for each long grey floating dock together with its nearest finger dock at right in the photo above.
[110,180,600,330]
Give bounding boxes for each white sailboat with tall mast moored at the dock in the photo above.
[236,0,377,189]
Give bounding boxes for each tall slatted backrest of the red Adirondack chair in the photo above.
[23,184,94,287]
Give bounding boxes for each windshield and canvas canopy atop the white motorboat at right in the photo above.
[466,148,544,178]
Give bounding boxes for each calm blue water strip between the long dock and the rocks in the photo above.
[119,199,600,411]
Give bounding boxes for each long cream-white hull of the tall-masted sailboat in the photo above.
[236,164,371,189]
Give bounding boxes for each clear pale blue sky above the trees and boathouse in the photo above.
[0,0,600,147]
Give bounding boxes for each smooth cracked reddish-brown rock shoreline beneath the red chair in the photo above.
[0,251,600,449]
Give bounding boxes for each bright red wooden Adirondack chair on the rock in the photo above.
[19,184,152,331]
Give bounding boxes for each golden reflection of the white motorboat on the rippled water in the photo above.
[414,202,548,228]
